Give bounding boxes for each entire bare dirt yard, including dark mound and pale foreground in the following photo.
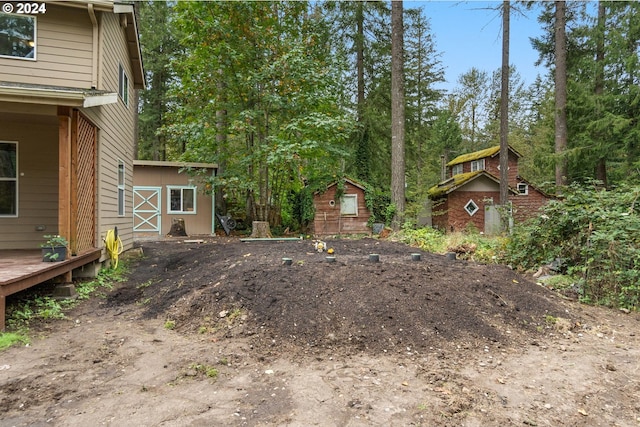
[0,237,640,427]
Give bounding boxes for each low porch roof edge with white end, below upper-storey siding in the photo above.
[0,82,118,108]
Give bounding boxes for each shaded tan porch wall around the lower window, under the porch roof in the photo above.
[0,113,58,249]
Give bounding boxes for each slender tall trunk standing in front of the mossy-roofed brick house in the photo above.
[500,0,511,207]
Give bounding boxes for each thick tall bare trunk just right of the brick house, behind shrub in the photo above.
[554,0,568,191]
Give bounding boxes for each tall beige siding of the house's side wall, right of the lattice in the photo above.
[83,13,135,254]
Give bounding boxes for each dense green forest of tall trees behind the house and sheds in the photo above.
[132,1,640,234]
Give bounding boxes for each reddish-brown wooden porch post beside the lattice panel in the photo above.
[58,107,72,246]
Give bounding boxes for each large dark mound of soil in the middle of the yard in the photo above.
[109,239,570,356]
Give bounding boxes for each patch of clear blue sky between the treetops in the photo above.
[404,0,546,90]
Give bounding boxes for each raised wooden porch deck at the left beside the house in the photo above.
[0,249,102,331]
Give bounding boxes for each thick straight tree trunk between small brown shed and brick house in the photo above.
[391,0,405,230]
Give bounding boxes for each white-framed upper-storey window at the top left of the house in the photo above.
[0,14,36,60]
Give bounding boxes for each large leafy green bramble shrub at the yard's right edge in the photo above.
[505,181,640,310]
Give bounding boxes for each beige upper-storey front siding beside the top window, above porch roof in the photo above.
[0,4,93,89]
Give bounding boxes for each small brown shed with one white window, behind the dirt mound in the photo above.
[313,179,371,236]
